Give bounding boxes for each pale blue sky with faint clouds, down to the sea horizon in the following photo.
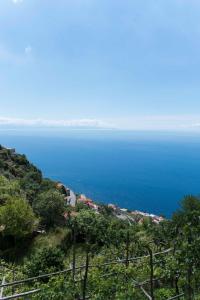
[0,0,200,131]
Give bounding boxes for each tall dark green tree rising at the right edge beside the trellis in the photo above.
[172,196,200,300]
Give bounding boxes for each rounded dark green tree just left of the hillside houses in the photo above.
[33,190,65,227]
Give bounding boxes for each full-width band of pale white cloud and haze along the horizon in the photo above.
[0,115,200,131]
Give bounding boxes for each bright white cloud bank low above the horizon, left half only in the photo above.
[0,117,112,128]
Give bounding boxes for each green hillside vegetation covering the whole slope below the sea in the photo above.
[0,147,200,300]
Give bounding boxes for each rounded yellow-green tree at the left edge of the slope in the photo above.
[0,197,37,239]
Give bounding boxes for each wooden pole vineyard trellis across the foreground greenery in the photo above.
[0,248,184,300]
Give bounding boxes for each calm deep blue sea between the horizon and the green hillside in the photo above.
[0,130,200,216]
